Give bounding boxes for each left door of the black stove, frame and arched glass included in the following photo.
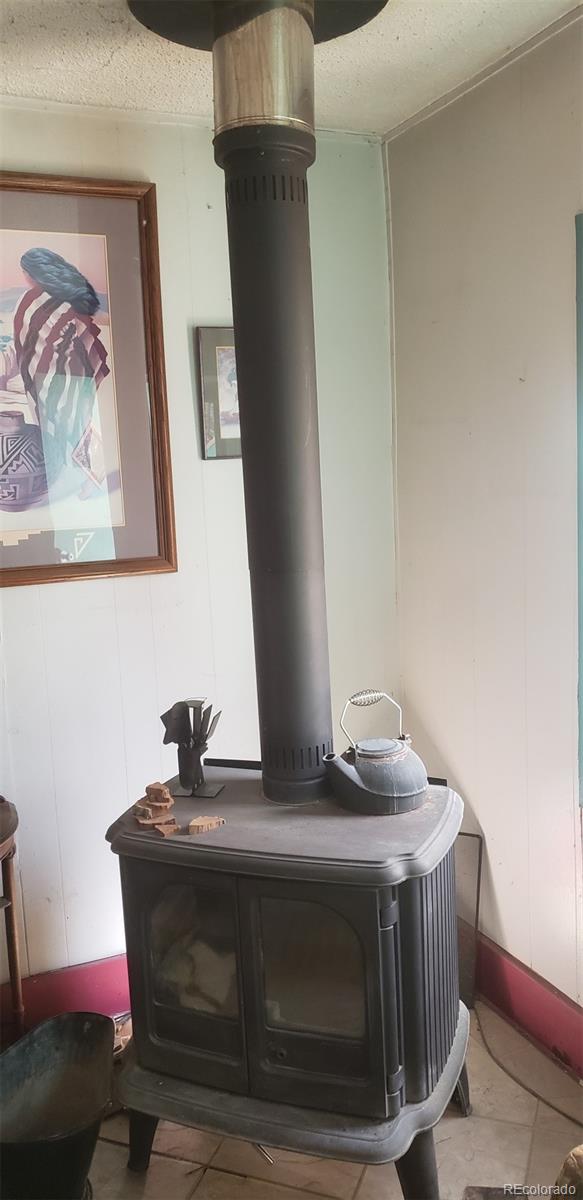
[121,858,248,1092]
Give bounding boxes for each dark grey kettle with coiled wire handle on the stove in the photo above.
[324,689,427,815]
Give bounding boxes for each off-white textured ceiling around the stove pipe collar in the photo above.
[0,0,575,133]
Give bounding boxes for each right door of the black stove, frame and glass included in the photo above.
[238,878,393,1118]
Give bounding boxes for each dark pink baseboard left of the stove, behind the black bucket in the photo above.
[0,954,130,1028]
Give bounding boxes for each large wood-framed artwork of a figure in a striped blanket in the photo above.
[0,172,176,587]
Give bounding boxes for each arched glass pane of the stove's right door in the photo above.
[260,896,366,1039]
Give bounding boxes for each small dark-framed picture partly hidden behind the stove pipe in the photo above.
[197,325,241,458]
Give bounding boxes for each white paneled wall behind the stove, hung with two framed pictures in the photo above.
[0,102,395,972]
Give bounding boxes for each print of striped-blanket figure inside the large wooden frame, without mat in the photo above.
[0,228,125,562]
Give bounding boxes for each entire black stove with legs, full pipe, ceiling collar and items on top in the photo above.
[108,0,469,1200]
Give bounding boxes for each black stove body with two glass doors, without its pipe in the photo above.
[108,767,468,1200]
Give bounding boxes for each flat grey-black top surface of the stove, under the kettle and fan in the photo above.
[107,767,463,887]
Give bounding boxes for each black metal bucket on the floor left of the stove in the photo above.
[0,1013,114,1200]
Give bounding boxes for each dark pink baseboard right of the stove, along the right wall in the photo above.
[476,934,583,1078]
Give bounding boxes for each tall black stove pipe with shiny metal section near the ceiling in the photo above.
[214,0,332,803]
